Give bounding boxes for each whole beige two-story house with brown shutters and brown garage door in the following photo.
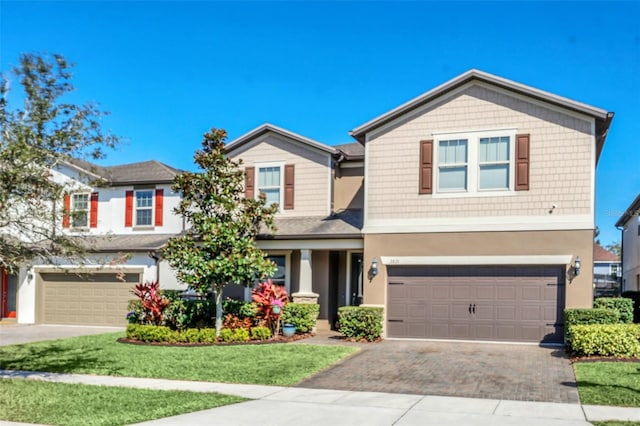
[227,70,613,342]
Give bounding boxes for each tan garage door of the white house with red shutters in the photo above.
[38,272,140,326]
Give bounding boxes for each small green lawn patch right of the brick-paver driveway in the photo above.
[573,362,640,407]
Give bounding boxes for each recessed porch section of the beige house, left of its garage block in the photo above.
[225,124,364,327]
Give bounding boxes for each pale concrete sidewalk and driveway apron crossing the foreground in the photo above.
[0,370,640,426]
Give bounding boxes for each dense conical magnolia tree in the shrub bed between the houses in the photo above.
[163,129,278,336]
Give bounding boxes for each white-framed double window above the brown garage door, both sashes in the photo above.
[434,129,516,197]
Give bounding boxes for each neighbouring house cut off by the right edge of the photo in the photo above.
[616,194,640,291]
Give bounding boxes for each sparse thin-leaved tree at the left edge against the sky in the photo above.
[0,54,118,272]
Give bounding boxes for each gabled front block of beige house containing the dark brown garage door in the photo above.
[351,70,613,342]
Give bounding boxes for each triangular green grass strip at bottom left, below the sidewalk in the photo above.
[0,379,245,426]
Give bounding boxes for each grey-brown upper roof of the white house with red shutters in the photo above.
[65,158,182,186]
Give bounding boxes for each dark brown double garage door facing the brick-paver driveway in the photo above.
[387,266,564,343]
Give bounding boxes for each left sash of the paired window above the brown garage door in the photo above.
[438,139,468,191]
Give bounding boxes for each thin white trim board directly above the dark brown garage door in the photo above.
[380,254,573,266]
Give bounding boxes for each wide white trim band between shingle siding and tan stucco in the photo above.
[362,215,593,234]
